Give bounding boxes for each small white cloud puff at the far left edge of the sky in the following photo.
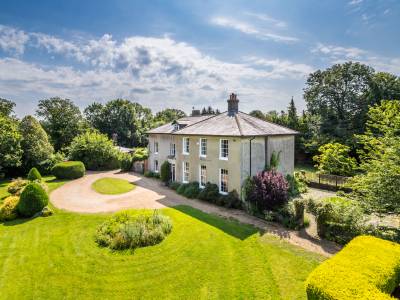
[0,25,29,55]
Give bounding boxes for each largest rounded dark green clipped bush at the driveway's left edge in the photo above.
[17,182,49,217]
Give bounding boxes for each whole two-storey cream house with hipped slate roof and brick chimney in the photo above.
[148,94,297,194]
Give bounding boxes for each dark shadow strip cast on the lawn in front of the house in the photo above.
[172,205,263,240]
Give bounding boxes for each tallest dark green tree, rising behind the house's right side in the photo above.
[304,62,374,144]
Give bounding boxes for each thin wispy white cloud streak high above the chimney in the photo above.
[211,16,298,43]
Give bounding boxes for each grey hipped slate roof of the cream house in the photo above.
[149,111,298,136]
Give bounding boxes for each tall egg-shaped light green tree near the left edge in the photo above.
[19,116,54,170]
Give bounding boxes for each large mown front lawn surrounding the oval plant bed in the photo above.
[0,206,322,299]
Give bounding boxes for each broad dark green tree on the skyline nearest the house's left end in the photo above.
[84,99,153,147]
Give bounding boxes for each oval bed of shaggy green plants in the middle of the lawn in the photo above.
[95,210,172,250]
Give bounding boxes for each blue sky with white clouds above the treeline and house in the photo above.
[0,0,400,116]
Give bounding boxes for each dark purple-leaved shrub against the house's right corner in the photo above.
[249,170,289,212]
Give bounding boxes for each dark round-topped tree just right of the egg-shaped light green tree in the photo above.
[36,97,84,151]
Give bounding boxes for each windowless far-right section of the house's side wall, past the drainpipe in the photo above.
[265,135,294,175]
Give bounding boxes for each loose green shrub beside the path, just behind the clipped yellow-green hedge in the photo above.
[307,197,366,244]
